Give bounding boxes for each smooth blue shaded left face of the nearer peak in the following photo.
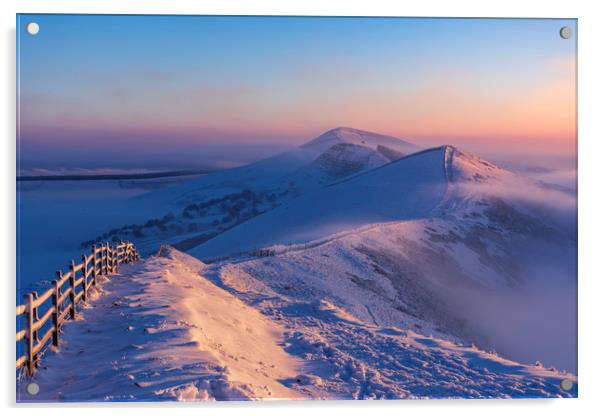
[190,148,447,259]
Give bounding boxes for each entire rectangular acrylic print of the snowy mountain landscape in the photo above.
[16,14,577,402]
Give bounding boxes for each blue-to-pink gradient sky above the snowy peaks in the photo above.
[17,15,577,168]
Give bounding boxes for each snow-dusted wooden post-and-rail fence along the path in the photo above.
[16,241,140,376]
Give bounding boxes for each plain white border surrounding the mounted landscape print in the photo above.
[0,0,602,416]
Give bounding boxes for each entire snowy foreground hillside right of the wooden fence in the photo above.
[18,249,576,401]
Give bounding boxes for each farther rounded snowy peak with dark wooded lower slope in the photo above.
[83,128,418,252]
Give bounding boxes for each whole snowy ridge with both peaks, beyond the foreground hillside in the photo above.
[74,129,576,380]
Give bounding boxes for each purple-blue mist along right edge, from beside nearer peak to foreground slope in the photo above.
[448,177,577,373]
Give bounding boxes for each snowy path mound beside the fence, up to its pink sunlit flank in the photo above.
[18,252,300,401]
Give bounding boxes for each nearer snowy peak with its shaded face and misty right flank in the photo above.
[189,146,576,370]
